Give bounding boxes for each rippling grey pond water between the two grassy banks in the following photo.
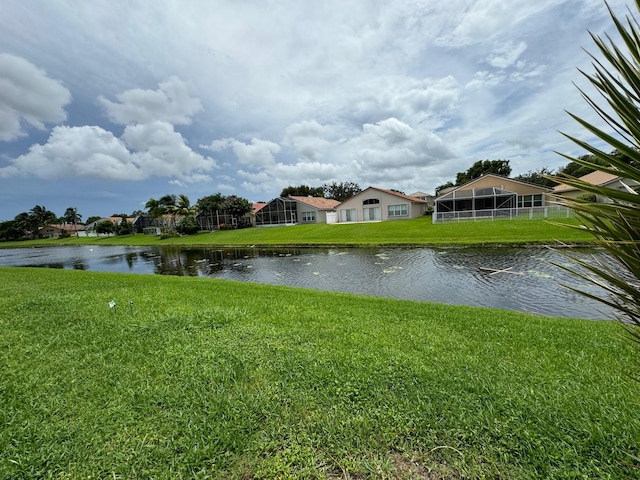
[0,246,614,319]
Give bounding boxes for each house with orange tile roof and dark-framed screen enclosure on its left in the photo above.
[254,195,340,227]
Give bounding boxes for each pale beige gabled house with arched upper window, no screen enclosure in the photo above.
[337,187,429,223]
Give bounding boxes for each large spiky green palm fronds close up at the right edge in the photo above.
[557,0,640,344]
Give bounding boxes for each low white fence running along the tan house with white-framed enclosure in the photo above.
[432,207,573,223]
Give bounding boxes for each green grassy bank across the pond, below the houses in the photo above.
[0,217,593,247]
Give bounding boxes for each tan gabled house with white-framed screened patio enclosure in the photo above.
[433,173,554,222]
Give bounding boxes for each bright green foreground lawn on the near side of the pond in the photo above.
[0,268,640,479]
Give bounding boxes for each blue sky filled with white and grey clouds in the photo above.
[0,0,626,220]
